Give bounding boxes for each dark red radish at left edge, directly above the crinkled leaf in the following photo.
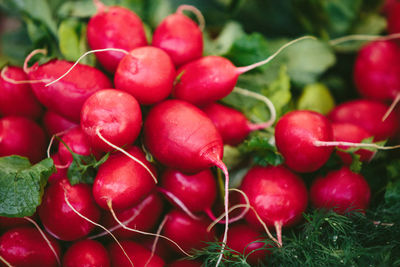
[0,116,46,163]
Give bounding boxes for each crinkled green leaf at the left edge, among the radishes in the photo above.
[0,156,55,217]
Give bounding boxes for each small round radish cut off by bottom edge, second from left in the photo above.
[63,240,110,267]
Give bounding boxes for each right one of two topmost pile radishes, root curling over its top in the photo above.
[152,5,203,66]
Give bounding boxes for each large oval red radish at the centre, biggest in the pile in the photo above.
[144,100,223,173]
